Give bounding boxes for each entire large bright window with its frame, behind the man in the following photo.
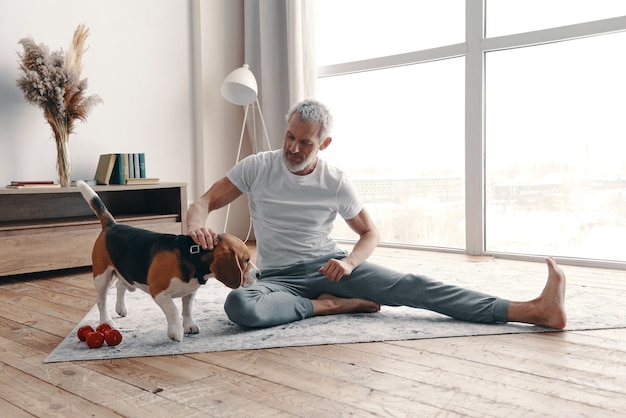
[316,0,626,265]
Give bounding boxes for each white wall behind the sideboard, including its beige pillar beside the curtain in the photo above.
[0,0,254,240]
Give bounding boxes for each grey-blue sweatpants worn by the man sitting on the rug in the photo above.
[224,251,509,327]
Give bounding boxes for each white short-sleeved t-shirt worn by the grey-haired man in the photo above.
[226,150,363,269]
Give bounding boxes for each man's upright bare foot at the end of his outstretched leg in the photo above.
[508,258,567,329]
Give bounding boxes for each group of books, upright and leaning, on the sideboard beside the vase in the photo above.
[94,152,159,185]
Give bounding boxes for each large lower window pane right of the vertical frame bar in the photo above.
[485,32,626,260]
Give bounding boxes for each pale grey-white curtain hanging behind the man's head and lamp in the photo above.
[244,0,317,150]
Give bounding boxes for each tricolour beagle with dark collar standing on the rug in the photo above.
[77,181,260,341]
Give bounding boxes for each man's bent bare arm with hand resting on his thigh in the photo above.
[319,209,380,282]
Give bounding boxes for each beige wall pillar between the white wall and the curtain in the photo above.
[193,0,251,238]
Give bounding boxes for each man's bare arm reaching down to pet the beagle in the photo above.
[187,177,242,250]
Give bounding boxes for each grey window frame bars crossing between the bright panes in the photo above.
[318,0,626,269]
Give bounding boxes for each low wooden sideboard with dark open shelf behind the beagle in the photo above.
[0,183,187,276]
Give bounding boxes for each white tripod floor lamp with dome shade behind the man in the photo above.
[220,64,272,233]
